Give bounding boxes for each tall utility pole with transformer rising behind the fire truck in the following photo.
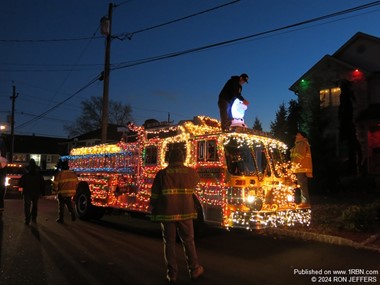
[100,3,113,143]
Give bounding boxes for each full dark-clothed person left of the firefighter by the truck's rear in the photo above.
[20,159,45,225]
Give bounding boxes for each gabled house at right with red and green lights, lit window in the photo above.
[289,32,380,175]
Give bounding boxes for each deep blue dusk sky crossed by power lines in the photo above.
[0,0,380,137]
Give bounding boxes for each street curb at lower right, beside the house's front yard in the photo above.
[266,226,380,253]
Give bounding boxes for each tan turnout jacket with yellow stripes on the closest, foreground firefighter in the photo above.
[150,163,199,221]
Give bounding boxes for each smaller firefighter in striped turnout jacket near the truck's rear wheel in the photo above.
[54,160,78,224]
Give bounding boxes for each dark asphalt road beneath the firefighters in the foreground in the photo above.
[0,195,380,285]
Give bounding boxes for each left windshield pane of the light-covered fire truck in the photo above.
[224,140,257,175]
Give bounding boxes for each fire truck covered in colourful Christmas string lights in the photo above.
[62,116,311,230]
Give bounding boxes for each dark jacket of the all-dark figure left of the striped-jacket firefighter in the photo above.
[20,170,45,198]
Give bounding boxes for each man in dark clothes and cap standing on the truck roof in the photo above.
[218,73,249,131]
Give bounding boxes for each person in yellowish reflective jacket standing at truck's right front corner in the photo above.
[290,132,313,204]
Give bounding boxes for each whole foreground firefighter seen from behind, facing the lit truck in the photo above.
[150,149,204,282]
